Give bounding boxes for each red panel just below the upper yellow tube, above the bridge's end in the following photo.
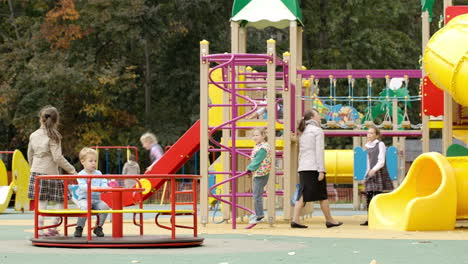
[421,76,444,116]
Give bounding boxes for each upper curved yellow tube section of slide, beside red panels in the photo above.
[423,14,468,106]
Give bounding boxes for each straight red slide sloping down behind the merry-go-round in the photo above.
[102,120,200,207]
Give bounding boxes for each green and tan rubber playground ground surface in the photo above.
[0,204,468,264]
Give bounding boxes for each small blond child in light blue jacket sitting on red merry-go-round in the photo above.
[74,148,109,237]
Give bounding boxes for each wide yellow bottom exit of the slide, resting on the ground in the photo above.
[369,152,468,231]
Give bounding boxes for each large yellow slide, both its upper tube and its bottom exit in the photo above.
[369,14,468,231]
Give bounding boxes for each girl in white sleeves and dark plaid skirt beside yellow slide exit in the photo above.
[361,126,393,226]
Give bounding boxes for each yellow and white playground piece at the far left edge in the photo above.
[0,150,29,213]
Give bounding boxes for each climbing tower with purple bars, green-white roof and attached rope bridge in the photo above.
[200,0,468,228]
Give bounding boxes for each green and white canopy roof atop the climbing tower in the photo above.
[231,0,303,28]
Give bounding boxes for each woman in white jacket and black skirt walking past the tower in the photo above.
[291,109,343,228]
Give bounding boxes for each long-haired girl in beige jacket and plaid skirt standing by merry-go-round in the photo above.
[28,106,76,236]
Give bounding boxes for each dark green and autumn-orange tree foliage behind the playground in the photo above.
[0,0,440,163]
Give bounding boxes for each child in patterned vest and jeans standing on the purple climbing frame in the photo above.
[247,128,272,224]
